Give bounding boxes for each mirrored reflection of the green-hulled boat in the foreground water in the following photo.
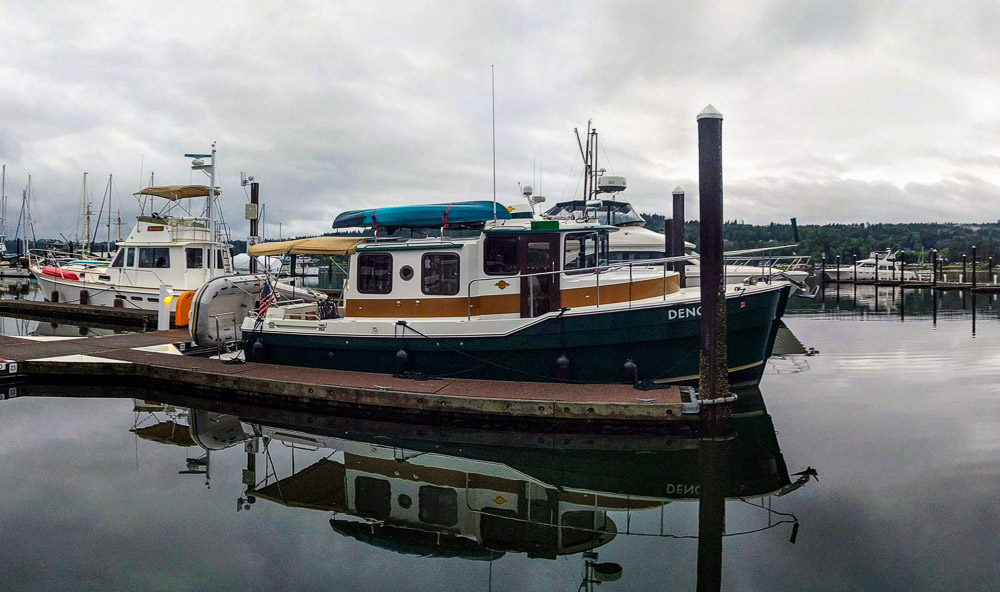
[125,389,815,589]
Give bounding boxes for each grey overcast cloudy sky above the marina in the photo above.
[0,0,1000,238]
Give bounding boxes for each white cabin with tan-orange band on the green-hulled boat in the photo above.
[343,219,679,318]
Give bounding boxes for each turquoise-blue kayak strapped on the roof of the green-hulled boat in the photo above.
[333,201,511,228]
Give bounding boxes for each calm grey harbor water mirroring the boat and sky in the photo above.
[0,280,1000,592]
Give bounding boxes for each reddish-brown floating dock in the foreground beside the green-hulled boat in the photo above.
[0,330,698,426]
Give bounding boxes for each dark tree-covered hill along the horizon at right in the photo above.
[642,214,1000,261]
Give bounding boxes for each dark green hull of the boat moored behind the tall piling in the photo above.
[243,286,790,386]
